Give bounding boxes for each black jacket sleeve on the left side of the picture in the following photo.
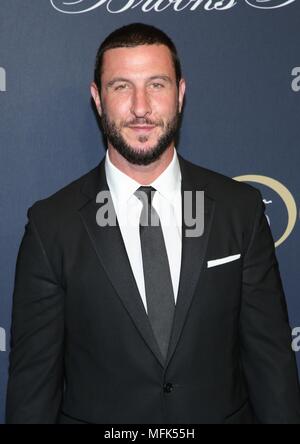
[6,208,64,424]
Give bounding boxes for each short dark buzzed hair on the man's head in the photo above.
[94,23,182,92]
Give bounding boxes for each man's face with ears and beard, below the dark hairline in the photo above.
[91,45,185,165]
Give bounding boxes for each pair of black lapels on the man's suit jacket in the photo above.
[79,155,214,368]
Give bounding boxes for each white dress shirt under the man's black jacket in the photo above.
[105,149,182,312]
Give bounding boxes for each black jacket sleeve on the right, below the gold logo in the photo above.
[240,192,300,424]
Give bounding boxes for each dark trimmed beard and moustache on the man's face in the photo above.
[101,106,180,165]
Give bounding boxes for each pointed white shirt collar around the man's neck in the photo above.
[105,149,181,206]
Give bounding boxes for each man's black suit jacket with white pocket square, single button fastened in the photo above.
[7,155,300,424]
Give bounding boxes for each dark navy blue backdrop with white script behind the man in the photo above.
[0,0,300,422]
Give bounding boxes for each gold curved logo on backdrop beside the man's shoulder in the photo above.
[234,174,297,247]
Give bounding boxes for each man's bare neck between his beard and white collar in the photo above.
[108,144,175,185]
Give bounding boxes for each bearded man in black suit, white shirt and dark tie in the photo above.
[7,24,300,424]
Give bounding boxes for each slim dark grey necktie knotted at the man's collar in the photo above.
[135,186,175,358]
